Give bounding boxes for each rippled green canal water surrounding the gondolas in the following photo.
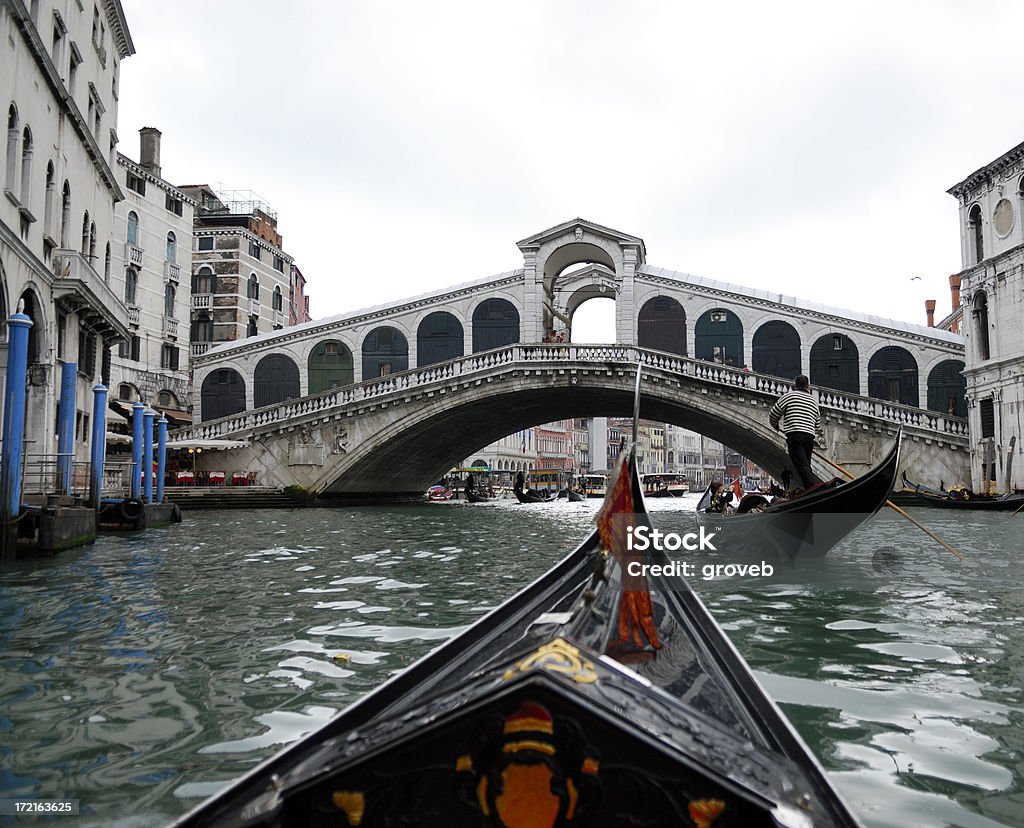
[0,496,1024,828]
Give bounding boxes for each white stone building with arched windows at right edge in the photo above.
[947,143,1024,491]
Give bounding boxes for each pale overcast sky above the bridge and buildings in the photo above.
[118,0,1024,335]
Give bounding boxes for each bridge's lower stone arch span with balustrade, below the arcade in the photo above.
[175,344,970,496]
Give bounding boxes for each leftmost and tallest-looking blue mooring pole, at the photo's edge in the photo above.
[0,311,32,561]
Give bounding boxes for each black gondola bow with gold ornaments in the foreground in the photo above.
[176,423,858,828]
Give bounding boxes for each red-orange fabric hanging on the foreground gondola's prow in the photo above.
[597,455,662,650]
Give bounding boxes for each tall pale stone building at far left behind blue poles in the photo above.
[0,0,134,473]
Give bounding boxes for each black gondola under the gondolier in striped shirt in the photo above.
[696,429,902,562]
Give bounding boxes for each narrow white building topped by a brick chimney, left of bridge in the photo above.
[111,127,196,419]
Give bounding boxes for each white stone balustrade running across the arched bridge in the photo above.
[184,344,967,440]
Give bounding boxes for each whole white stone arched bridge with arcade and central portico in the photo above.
[179,219,970,493]
